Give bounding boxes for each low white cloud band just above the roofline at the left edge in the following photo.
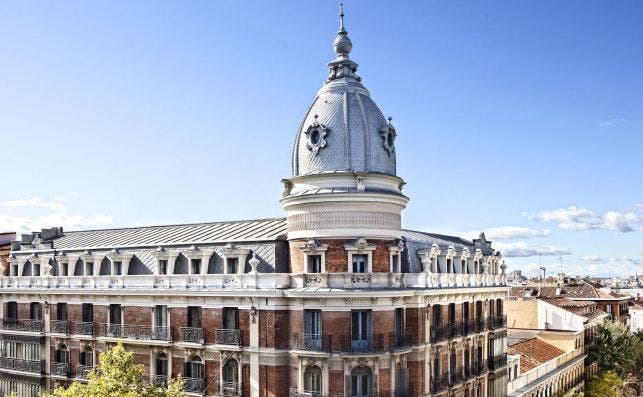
[0,213,113,233]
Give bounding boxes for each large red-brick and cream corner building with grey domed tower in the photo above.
[0,8,508,397]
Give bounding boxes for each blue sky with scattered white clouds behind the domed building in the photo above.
[0,0,643,276]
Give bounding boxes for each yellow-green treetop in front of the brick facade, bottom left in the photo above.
[46,342,185,397]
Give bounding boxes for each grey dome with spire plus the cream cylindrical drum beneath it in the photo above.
[281,6,408,251]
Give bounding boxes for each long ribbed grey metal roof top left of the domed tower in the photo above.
[45,218,286,249]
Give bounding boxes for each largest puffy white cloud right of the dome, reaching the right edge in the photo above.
[523,205,643,233]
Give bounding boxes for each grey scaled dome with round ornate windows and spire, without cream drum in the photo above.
[292,7,396,176]
